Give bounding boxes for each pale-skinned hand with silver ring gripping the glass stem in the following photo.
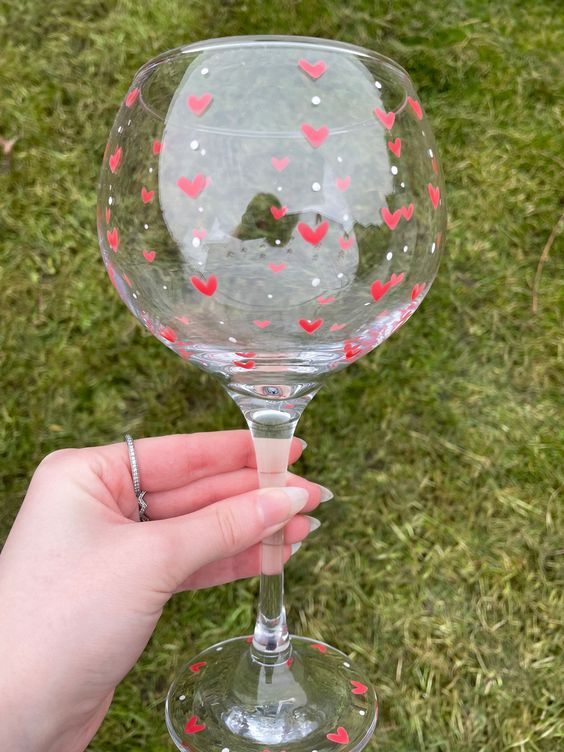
[0,431,324,752]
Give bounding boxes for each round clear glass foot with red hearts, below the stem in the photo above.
[166,636,378,752]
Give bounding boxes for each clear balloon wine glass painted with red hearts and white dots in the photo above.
[98,36,446,752]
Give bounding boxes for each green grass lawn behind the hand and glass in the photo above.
[0,0,564,752]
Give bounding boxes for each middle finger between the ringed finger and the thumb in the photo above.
[145,468,330,520]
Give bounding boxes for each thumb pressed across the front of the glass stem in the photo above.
[140,486,309,592]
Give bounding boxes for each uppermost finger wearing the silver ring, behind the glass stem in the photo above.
[93,430,305,500]
